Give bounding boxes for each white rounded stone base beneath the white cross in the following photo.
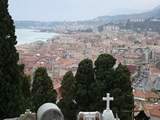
[102,110,115,120]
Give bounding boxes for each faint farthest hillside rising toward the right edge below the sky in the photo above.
[93,6,160,22]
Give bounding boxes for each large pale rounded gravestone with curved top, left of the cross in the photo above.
[37,103,64,120]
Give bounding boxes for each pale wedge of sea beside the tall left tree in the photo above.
[16,29,58,45]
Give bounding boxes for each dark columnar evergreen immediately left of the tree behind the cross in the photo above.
[75,59,94,111]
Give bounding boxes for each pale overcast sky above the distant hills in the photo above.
[9,0,160,21]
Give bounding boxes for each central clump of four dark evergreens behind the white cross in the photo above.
[60,54,134,120]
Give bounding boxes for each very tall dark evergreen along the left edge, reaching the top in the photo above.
[0,0,23,119]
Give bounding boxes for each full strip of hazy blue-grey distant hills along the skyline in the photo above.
[15,6,160,31]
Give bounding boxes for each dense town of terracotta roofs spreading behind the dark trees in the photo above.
[17,19,160,120]
